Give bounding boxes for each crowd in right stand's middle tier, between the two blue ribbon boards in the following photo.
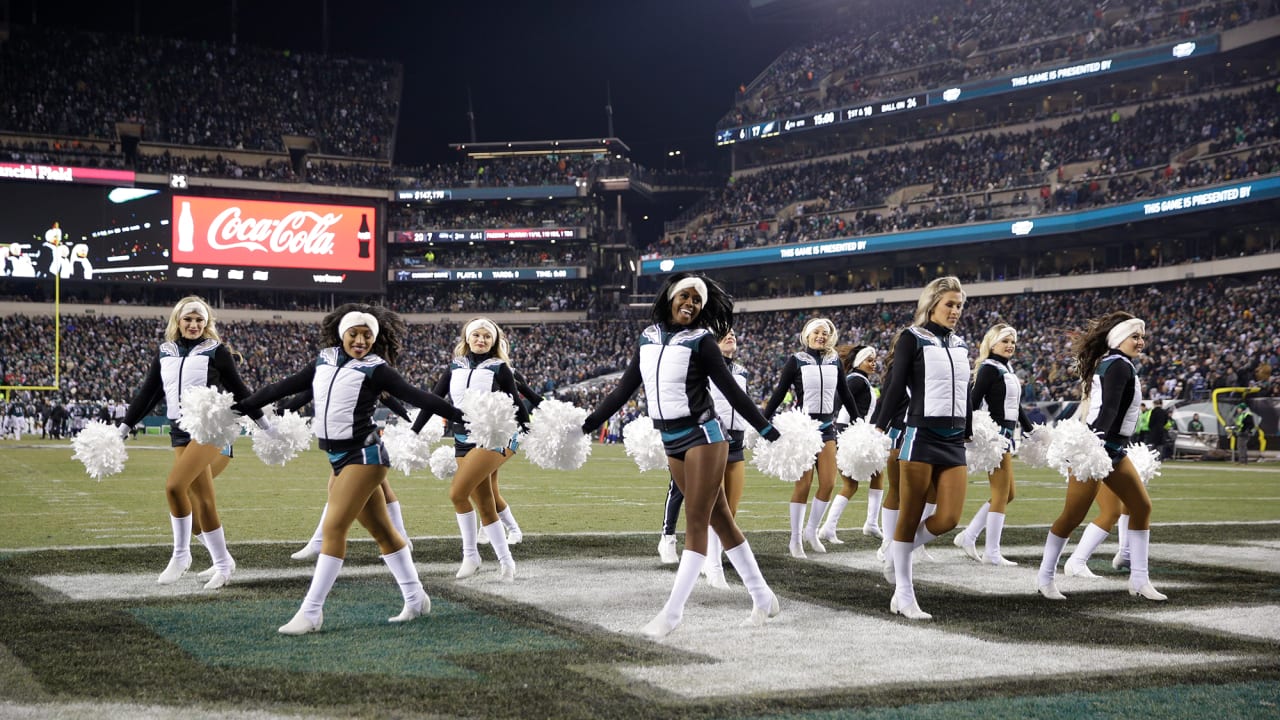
[646,87,1280,256]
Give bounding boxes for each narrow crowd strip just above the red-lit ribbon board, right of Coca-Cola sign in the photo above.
[387,202,596,231]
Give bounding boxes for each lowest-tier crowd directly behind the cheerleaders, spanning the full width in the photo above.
[0,275,1280,427]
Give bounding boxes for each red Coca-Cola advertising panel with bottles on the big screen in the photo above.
[173,195,378,272]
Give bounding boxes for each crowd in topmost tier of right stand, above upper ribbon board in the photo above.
[718,0,1275,128]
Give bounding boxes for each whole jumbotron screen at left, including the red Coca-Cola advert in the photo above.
[0,176,387,292]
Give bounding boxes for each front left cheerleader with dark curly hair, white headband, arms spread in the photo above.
[236,304,461,635]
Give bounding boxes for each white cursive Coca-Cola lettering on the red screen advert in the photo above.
[209,206,342,255]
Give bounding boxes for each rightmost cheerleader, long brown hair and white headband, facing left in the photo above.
[1036,311,1167,601]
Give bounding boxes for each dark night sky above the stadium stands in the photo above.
[9,0,806,168]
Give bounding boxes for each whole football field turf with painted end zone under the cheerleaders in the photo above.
[0,437,1280,719]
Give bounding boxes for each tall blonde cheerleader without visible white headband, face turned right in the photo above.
[876,277,973,620]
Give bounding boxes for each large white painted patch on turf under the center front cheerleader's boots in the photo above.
[455,560,1243,698]
